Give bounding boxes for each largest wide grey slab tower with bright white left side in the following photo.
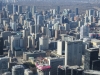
[65,40,83,66]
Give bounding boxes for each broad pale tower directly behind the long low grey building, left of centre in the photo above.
[39,36,49,50]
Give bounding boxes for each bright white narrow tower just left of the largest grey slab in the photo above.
[57,40,65,55]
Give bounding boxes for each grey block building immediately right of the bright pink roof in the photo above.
[46,57,64,75]
